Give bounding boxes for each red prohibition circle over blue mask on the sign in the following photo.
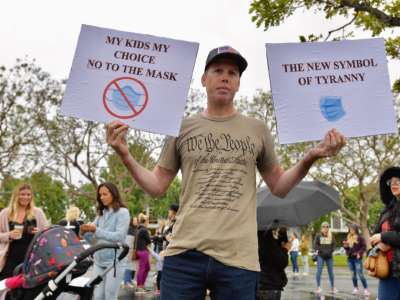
[103,77,149,119]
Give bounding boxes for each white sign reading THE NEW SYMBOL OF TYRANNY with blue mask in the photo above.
[266,38,397,144]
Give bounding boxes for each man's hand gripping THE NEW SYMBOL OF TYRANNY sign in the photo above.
[311,129,346,158]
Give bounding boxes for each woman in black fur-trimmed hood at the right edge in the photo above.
[370,167,400,300]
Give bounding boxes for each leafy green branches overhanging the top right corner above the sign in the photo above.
[249,0,400,92]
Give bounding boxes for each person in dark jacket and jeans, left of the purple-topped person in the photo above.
[314,222,338,294]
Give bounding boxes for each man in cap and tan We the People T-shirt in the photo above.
[107,46,345,300]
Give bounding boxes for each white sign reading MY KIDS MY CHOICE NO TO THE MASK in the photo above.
[61,25,199,136]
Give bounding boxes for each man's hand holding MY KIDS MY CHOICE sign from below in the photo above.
[106,121,129,157]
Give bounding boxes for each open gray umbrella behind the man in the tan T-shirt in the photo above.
[256,181,340,230]
